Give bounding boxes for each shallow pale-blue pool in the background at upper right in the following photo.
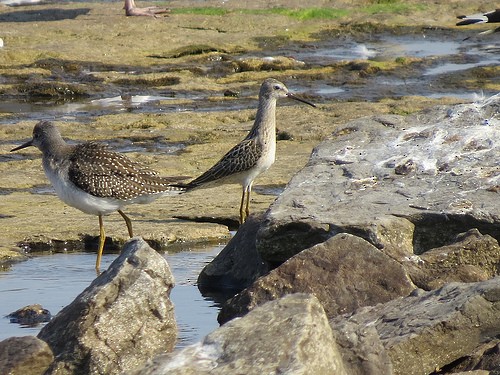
[270,30,500,101]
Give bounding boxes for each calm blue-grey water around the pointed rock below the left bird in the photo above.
[0,245,224,348]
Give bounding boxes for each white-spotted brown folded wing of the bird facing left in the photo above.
[68,142,181,200]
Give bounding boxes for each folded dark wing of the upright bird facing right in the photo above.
[187,139,262,188]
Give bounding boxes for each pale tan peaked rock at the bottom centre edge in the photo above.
[133,294,347,375]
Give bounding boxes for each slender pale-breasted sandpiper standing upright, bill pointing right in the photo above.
[179,78,316,224]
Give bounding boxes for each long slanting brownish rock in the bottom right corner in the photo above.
[330,277,500,374]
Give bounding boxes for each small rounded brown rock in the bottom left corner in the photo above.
[0,336,54,375]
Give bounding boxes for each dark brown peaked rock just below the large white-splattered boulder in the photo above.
[218,233,415,324]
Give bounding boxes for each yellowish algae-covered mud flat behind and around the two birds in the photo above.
[0,1,500,266]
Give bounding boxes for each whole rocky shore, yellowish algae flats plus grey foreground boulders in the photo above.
[0,1,500,375]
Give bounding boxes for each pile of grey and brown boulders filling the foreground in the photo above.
[0,96,500,375]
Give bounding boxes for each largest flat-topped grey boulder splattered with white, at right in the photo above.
[256,95,500,263]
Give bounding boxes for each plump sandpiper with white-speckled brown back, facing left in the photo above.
[11,121,188,272]
